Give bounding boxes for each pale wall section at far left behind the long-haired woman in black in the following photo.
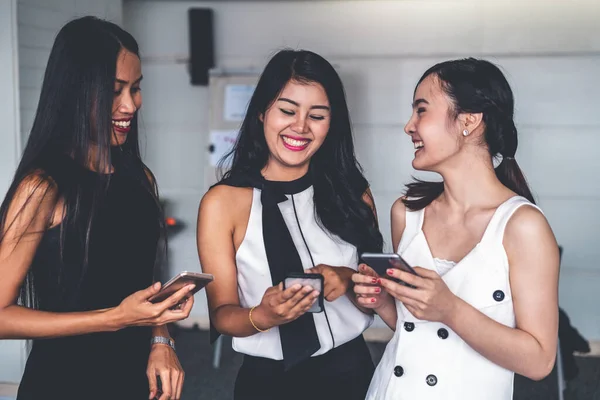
[0,0,122,382]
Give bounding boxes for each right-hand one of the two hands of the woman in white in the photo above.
[381,267,457,324]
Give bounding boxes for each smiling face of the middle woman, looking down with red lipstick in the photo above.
[261,80,331,176]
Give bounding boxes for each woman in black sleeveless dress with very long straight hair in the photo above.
[0,17,193,400]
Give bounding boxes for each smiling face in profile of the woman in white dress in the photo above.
[404,75,464,172]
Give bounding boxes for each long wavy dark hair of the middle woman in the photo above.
[221,50,383,254]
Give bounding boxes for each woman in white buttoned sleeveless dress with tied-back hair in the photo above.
[353,59,559,400]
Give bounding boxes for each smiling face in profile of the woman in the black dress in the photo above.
[111,49,142,146]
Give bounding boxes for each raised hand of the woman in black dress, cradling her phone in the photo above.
[114,282,195,327]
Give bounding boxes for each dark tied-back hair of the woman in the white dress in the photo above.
[403,58,535,210]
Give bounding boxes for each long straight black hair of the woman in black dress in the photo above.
[0,16,165,307]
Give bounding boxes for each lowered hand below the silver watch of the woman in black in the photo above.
[146,344,185,400]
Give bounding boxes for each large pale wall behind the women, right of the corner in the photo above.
[123,0,600,339]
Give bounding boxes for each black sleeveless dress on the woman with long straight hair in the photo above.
[17,156,160,400]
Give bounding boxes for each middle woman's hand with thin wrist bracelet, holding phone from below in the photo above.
[252,284,319,330]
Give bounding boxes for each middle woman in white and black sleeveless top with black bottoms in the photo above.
[198,50,382,399]
